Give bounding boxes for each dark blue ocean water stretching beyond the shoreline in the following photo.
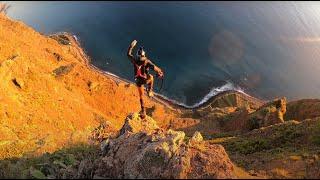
[7,2,320,107]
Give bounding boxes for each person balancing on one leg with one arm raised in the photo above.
[127,40,163,118]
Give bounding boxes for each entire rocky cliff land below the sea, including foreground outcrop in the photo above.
[0,14,320,178]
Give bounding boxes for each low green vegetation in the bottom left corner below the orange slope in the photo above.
[0,144,99,179]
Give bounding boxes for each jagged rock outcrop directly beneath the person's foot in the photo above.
[94,114,234,178]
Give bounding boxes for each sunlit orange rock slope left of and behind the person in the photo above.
[0,15,178,159]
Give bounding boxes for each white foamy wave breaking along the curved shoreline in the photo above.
[157,82,249,108]
